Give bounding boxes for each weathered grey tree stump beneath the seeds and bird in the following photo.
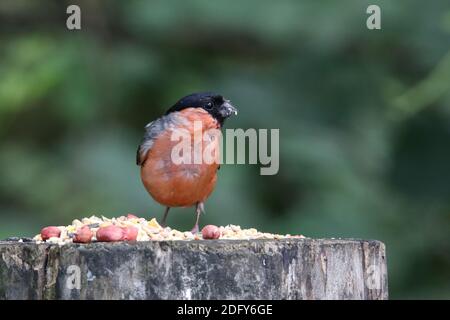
[0,239,388,299]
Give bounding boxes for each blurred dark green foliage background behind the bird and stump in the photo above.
[0,0,450,298]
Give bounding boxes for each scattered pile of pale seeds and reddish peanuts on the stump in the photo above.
[33,214,303,245]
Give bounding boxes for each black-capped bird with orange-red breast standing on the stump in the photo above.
[136,92,237,234]
